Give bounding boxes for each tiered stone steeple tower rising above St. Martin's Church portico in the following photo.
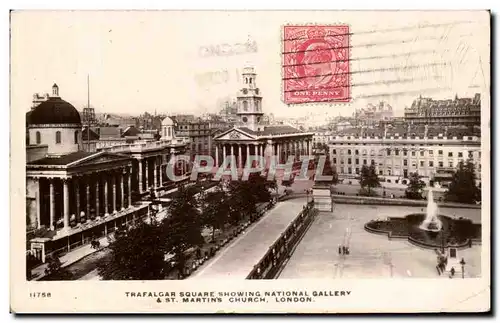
[237,67,264,131]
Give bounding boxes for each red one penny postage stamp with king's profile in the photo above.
[282,25,351,104]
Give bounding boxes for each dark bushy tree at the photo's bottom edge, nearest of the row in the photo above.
[98,223,168,280]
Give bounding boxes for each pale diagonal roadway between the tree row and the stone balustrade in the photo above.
[188,198,306,280]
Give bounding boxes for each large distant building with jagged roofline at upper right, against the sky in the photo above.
[404,93,481,126]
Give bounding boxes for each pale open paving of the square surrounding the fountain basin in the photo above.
[279,204,481,279]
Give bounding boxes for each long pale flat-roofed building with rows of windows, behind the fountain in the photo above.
[329,128,481,184]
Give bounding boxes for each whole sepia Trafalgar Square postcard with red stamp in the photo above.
[11,10,490,312]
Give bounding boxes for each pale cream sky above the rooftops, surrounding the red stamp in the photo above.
[11,11,489,119]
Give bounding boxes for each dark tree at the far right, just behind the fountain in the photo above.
[446,159,480,203]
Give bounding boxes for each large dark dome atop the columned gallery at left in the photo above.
[27,97,82,125]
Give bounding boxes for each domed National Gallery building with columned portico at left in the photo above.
[26,84,191,261]
